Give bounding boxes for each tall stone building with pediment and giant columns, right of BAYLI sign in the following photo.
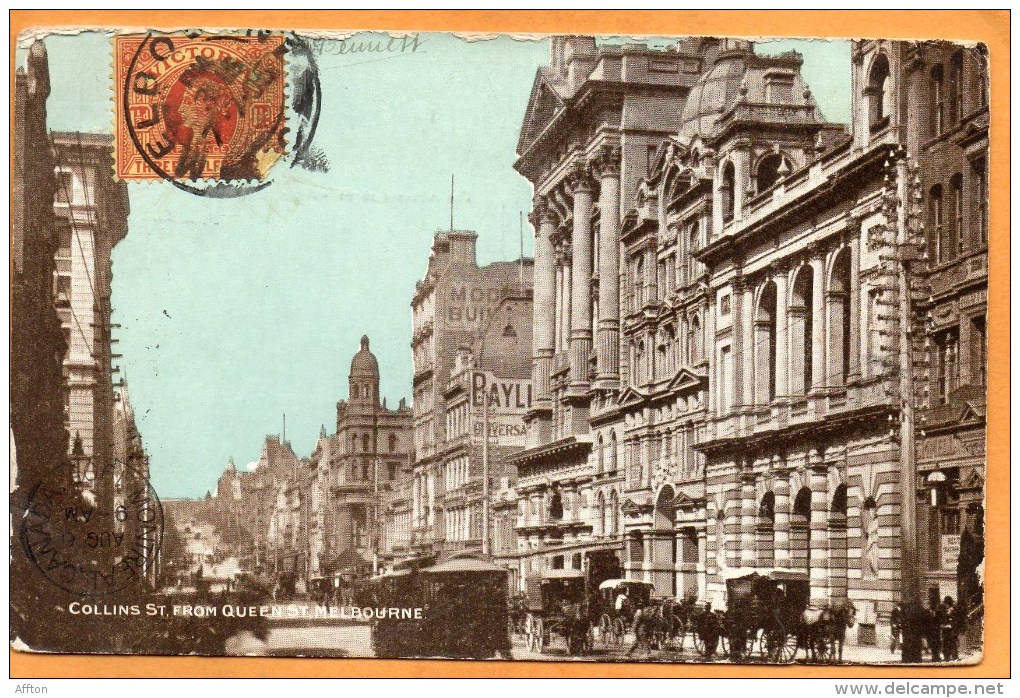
[514,37,718,591]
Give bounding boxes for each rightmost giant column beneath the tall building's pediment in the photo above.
[593,146,620,388]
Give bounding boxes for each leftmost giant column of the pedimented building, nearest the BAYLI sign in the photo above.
[528,197,556,406]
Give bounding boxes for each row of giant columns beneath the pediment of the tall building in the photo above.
[530,145,620,406]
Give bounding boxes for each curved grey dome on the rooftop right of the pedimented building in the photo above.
[679,40,754,144]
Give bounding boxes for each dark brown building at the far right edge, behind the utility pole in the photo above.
[904,43,988,638]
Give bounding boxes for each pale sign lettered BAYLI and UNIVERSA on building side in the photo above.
[471,370,531,447]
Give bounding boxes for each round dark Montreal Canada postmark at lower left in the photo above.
[20,464,163,597]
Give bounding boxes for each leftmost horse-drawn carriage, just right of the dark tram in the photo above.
[524,569,592,654]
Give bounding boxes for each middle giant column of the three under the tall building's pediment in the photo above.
[570,167,595,391]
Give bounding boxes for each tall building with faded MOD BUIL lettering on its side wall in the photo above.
[411,231,532,557]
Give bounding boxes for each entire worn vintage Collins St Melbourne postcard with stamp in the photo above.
[10,15,1005,677]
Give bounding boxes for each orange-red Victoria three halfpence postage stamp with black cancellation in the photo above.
[113,33,286,181]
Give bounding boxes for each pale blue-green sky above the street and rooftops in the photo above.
[27,28,850,497]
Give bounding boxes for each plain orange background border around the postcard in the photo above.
[10,10,1010,680]
